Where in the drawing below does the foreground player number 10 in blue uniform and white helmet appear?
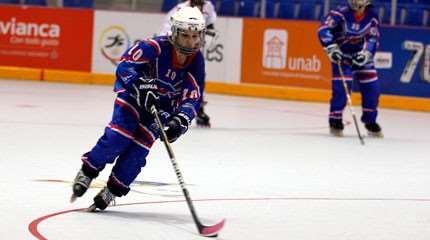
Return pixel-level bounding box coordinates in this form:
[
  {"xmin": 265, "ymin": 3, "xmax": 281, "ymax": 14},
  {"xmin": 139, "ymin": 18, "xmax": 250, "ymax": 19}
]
[{"xmin": 71, "ymin": 7, "xmax": 205, "ymax": 210}]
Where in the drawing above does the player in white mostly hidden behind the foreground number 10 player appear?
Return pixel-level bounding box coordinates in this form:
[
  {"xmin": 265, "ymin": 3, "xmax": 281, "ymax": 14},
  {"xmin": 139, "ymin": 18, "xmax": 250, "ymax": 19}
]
[{"xmin": 159, "ymin": 0, "xmax": 218, "ymax": 127}]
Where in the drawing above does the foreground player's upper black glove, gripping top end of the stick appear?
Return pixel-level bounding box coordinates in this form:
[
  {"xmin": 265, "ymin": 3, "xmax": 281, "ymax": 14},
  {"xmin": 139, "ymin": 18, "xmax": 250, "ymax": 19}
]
[{"xmin": 133, "ymin": 78, "xmax": 160, "ymax": 112}]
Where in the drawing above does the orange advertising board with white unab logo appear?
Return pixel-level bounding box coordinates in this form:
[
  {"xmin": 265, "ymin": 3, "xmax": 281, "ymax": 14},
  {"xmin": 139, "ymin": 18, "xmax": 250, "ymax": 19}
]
[{"xmin": 241, "ymin": 19, "xmax": 331, "ymax": 89}]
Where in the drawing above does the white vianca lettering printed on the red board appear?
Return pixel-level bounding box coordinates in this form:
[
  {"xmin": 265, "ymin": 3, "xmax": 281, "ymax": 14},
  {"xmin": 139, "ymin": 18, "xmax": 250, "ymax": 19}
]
[{"xmin": 0, "ymin": 17, "xmax": 61, "ymax": 38}]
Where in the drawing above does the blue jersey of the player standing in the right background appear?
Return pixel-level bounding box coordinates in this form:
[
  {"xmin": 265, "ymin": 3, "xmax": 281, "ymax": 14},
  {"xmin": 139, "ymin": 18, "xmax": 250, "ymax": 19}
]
[{"xmin": 318, "ymin": 6, "xmax": 379, "ymax": 56}]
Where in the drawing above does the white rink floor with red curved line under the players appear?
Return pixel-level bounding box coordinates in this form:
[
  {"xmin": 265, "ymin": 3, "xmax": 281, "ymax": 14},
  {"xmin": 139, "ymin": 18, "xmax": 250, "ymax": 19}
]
[{"xmin": 0, "ymin": 80, "xmax": 430, "ymax": 240}]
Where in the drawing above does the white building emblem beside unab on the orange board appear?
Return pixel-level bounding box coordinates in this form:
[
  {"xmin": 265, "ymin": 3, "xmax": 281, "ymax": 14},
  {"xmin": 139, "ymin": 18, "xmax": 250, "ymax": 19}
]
[{"xmin": 263, "ymin": 29, "xmax": 288, "ymax": 69}]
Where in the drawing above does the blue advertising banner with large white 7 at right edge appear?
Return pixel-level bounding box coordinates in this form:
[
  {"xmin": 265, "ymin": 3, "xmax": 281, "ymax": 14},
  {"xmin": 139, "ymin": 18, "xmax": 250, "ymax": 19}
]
[{"xmin": 376, "ymin": 27, "xmax": 430, "ymax": 98}]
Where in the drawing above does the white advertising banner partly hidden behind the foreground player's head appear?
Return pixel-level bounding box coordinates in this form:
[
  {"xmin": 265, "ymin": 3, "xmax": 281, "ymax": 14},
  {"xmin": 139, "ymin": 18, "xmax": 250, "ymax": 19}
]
[{"xmin": 92, "ymin": 11, "xmax": 242, "ymax": 83}]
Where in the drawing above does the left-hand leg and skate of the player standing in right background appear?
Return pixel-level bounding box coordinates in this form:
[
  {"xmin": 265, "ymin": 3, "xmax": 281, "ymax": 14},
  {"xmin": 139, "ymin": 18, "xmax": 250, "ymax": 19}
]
[{"xmin": 329, "ymin": 64, "xmax": 352, "ymax": 136}]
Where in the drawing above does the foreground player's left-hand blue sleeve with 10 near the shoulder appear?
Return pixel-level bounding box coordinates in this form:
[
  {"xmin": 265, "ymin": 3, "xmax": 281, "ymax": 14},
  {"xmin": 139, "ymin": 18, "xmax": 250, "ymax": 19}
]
[{"xmin": 115, "ymin": 39, "xmax": 161, "ymax": 91}]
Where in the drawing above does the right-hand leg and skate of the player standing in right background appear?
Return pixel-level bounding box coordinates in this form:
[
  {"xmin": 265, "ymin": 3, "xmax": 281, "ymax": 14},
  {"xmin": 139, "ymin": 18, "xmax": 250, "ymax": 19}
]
[{"xmin": 355, "ymin": 69, "xmax": 383, "ymax": 137}]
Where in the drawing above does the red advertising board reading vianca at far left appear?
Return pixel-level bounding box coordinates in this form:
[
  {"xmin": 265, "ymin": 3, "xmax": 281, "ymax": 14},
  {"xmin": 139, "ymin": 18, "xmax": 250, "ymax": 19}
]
[{"xmin": 0, "ymin": 6, "xmax": 93, "ymax": 71}]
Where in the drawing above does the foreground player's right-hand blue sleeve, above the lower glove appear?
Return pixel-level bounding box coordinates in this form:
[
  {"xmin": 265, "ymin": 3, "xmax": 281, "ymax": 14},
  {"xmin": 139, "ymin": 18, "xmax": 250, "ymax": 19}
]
[{"xmin": 179, "ymin": 53, "xmax": 205, "ymax": 122}]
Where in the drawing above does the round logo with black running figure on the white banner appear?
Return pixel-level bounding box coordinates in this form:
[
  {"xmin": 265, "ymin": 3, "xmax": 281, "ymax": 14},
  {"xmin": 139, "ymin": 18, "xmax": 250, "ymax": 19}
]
[{"xmin": 99, "ymin": 25, "xmax": 130, "ymax": 66}]
